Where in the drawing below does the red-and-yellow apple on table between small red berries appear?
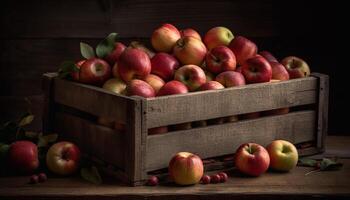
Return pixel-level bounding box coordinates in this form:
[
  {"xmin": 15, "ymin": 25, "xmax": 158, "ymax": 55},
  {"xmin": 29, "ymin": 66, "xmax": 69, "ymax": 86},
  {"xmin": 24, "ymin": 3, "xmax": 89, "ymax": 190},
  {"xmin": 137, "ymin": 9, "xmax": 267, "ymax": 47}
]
[{"xmin": 168, "ymin": 152, "xmax": 204, "ymax": 185}]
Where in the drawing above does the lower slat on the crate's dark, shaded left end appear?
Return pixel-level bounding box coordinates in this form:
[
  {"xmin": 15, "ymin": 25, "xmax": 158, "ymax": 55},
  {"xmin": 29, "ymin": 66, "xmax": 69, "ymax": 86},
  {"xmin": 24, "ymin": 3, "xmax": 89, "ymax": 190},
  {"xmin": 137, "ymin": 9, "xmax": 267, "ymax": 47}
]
[{"xmin": 54, "ymin": 112, "xmax": 124, "ymax": 169}]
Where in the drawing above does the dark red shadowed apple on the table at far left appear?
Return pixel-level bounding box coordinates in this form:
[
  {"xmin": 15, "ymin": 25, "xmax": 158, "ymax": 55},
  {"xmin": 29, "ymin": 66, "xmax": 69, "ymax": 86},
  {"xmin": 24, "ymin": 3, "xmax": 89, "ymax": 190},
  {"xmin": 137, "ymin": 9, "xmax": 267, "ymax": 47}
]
[{"xmin": 8, "ymin": 141, "xmax": 39, "ymax": 174}]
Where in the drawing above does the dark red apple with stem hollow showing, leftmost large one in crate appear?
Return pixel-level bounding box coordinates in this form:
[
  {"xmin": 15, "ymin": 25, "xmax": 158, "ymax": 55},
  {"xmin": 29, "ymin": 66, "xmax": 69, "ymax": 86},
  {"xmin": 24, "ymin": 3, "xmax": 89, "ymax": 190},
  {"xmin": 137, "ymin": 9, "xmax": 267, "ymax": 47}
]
[{"xmin": 79, "ymin": 58, "xmax": 112, "ymax": 85}]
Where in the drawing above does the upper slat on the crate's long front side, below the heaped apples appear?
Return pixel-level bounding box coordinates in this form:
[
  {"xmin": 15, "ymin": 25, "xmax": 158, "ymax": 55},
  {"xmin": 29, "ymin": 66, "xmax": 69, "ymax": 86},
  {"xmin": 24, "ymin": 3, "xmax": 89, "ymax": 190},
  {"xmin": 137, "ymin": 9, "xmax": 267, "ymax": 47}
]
[{"xmin": 146, "ymin": 77, "xmax": 317, "ymax": 128}]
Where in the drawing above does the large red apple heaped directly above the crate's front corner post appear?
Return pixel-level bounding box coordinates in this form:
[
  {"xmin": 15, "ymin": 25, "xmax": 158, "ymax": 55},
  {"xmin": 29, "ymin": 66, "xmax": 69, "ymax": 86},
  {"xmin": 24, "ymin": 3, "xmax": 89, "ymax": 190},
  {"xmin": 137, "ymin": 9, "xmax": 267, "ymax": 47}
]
[{"xmin": 117, "ymin": 48, "xmax": 151, "ymax": 82}]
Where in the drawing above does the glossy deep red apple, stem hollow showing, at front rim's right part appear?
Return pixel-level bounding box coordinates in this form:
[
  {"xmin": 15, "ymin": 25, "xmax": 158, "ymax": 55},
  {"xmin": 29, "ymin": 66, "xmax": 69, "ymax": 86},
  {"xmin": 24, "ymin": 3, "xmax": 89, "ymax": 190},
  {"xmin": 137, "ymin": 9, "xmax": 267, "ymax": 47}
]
[{"xmin": 242, "ymin": 56, "xmax": 272, "ymax": 83}]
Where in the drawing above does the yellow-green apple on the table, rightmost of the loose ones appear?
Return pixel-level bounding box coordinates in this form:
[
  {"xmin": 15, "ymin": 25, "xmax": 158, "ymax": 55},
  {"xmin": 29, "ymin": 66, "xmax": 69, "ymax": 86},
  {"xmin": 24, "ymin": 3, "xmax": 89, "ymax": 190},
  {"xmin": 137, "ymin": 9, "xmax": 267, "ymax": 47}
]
[{"xmin": 266, "ymin": 140, "xmax": 298, "ymax": 172}]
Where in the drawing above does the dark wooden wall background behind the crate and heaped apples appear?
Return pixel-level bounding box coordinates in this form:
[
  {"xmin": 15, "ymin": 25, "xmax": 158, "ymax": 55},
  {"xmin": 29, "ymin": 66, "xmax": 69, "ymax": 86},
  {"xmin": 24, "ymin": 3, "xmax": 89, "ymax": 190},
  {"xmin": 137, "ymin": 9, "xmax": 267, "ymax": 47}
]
[{"xmin": 0, "ymin": 0, "xmax": 350, "ymax": 135}]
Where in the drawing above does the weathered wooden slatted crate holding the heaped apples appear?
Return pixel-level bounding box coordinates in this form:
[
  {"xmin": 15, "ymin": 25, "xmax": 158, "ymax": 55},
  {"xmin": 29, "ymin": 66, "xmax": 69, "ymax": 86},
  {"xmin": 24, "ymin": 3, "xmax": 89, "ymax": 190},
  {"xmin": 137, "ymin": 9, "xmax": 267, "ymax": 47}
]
[{"xmin": 43, "ymin": 73, "xmax": 329, "ymax": 185}]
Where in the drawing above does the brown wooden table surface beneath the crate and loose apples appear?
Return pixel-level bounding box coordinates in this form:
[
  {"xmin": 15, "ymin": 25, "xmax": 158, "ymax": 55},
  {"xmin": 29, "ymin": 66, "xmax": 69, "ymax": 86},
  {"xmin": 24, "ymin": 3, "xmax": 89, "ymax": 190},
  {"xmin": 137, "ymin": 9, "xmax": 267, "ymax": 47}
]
[{"xmin": 0, "ymin": 136, "xmax": 350, "ymax": 200}]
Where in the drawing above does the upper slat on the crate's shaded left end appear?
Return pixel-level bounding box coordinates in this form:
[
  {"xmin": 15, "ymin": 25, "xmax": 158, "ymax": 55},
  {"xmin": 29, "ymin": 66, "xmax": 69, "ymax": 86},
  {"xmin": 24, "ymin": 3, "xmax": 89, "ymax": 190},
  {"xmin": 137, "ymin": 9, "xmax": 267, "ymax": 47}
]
[{"xmin": 54, "ymin": 78, "xmax": 134, "ymax": 122}]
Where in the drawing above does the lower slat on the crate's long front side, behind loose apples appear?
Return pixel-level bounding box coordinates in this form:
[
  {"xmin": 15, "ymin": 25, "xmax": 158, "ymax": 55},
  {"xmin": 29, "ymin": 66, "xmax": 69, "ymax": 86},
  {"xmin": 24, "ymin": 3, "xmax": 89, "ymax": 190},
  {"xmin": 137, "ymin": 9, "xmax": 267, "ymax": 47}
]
[{"xmin": 146, "ymin": 111, "xmax": 316, "ymax": 171}]
